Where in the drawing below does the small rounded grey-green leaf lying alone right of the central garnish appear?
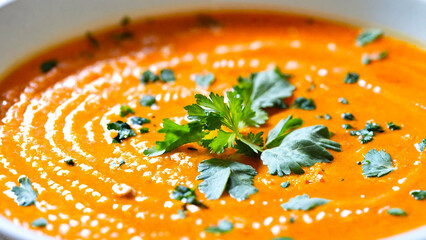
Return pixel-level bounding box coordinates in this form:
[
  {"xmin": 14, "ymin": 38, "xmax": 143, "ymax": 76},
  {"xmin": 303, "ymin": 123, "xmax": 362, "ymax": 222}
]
[{"xmin": 362, "ymin": 149, "xmax": 394, "ymax": 177}]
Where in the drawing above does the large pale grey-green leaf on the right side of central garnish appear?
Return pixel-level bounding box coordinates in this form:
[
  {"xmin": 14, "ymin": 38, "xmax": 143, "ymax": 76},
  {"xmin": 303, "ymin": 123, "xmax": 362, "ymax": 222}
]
[{"xmin": 260, "ymin": 125, "xmax": 341, "ymax": 177}]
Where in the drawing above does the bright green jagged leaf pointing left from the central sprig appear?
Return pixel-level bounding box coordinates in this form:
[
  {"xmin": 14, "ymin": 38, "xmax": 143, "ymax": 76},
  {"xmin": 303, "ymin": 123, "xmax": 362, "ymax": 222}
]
[{"xmin": 143, "ymin": 119, "xmax": 206, "ymax": 157}]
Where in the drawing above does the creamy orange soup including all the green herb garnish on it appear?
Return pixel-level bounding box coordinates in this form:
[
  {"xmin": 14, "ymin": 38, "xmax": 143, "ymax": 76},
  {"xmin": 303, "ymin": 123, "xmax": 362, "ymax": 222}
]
[{"xmin": 0, "ymin": 12, "xmax": 426, "ymax": 240}]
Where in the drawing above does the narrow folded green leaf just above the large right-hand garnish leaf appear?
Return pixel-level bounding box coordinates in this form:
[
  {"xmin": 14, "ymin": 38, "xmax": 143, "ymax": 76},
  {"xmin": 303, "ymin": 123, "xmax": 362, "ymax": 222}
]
[{"xmin": 265, "ymin": 115, "xmax": 303, "ymax": 148}]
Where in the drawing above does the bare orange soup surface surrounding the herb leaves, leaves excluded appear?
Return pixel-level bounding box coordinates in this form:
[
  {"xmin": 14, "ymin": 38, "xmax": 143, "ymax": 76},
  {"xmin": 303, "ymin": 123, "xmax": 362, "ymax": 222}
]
[{"xmin": 0, "ymin": 12, "xmax": 426, "ymax": 240}]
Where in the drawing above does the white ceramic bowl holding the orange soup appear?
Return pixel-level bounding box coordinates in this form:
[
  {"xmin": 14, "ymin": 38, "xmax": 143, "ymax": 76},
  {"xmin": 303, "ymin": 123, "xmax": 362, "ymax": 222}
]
[{"xmin": 0, "ymin": 0, "xmax": 426, "ymax": 240}]
